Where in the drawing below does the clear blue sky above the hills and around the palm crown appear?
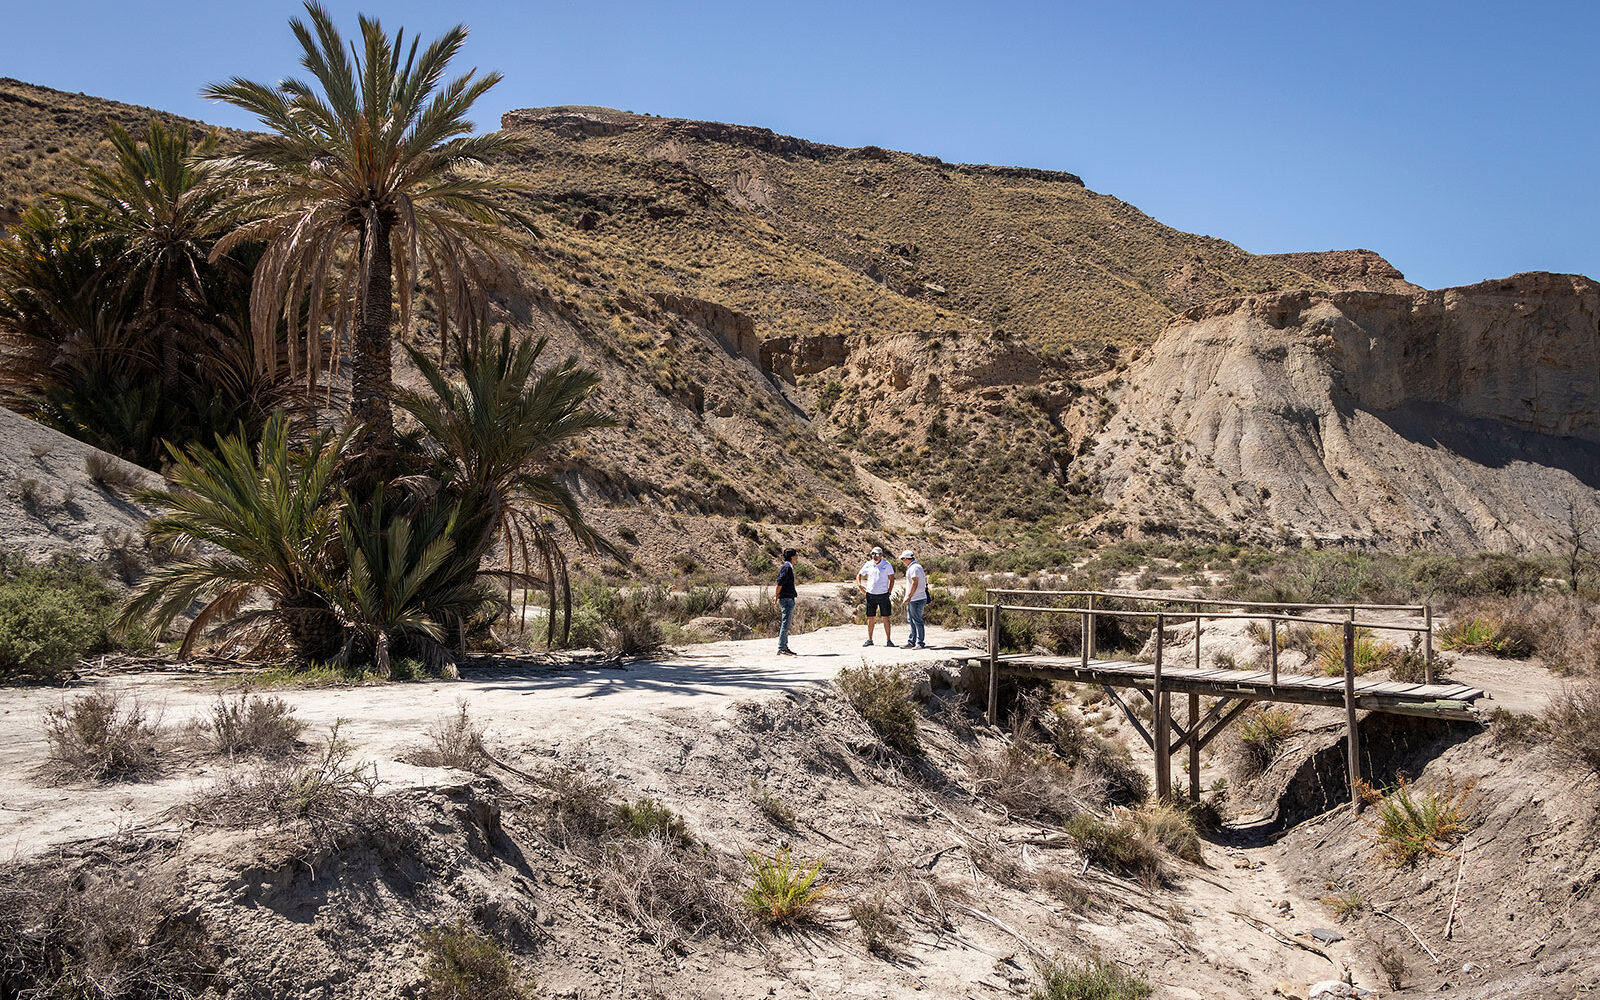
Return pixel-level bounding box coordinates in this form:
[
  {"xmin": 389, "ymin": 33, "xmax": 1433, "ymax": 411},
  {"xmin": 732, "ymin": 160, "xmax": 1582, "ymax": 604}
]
[{"xmin": 0, "ymin": 0, "xmax": 1600, "ymax": 288}]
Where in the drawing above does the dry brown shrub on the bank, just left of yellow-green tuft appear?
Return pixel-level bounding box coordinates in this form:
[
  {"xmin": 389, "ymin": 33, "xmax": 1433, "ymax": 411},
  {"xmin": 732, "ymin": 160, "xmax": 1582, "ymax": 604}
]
[{"xmin": 597, "ymin": 832, "xmax": 746, "ymax": 947}]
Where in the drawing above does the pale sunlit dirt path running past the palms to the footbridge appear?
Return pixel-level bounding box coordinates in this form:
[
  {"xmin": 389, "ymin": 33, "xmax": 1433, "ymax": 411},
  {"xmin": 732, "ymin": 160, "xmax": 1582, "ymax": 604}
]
[{"xmin": 0, "ymin": 626, "xmax": 981, "ymax": 858}]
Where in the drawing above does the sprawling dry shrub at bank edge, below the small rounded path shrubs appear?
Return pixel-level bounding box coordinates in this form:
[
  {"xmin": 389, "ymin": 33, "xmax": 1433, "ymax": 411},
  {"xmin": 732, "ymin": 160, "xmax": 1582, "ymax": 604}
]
[{"xmin": 187, "ymin": 723, "xmax": 418, "ymax": 853}]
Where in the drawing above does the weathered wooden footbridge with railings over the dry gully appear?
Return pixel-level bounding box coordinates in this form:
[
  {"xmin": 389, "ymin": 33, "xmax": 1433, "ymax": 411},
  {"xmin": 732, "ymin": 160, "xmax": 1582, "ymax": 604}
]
[{"xmin": 973, "ymin": 589, "xmax": 1485, "ymax": 810}]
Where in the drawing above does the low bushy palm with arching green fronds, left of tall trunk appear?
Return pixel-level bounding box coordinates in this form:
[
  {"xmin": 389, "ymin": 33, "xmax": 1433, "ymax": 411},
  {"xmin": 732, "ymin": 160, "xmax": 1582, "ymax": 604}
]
[{"xmin": 115, "ymin": 411, "xmax": 349, "ymax": 659}]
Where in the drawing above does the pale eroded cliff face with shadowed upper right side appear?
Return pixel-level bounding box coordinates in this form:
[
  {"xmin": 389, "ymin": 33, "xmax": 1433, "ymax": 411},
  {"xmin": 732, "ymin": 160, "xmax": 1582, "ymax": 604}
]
[{"xmin": 1093, "ymin": 274, "xmax": 1600, "ymax": 550}]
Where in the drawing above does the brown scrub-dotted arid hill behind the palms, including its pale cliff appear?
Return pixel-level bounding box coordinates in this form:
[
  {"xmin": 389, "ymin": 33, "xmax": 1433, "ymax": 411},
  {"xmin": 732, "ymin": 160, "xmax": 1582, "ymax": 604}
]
[{"xmin": 0, "ymin": 80, "xmax": 1595, "ymax": 573}]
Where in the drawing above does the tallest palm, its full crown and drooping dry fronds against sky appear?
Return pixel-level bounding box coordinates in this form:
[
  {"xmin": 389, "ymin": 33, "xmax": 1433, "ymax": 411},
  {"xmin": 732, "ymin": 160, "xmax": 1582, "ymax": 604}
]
[{"xmin": 203, "ymin": 2, "xmax": 531, "ymax": 453}]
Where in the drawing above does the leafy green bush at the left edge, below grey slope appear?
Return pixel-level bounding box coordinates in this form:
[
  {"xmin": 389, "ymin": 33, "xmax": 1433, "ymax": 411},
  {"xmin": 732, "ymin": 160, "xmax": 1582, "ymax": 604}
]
[{"xmin": 0, "ymin": 554, "xmax": 117, "ymax": 678}]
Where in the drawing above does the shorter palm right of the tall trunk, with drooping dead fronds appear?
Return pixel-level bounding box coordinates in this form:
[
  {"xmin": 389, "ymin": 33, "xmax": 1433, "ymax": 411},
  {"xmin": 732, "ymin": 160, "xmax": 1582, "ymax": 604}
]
[{"xmin": 395, "ymin": 330, "xmax": 616, "ymax": 642}]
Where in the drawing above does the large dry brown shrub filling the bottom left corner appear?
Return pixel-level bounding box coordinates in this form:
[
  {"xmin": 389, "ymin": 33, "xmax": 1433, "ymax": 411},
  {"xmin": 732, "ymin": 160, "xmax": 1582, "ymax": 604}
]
[{"xmin": 0, "ymin": 854, "xmax": 221, "ymax": 1000}]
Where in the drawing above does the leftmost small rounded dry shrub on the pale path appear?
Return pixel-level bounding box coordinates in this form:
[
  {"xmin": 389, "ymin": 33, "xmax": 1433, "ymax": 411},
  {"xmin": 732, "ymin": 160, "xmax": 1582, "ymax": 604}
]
[{"xmin": 43, "ymin": 691, "xmax": 165, "ymax": 782}]
